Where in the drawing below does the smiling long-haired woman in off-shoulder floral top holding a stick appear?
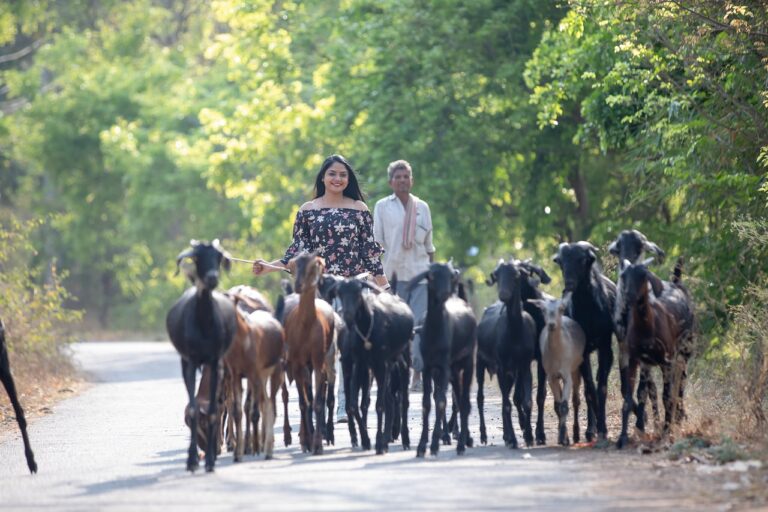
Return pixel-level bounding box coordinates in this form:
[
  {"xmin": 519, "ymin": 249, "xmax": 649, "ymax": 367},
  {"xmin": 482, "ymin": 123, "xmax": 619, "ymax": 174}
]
[{"xmin": 253, "ymin": 155, "xmax": 389, "ymax": 289}]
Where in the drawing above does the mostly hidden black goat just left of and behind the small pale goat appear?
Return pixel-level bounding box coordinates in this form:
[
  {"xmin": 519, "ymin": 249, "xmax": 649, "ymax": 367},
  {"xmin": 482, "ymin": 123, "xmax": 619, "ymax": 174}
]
[{"xmin": 518, "ymin": 260, "xmax": 552, "ymax": 445}]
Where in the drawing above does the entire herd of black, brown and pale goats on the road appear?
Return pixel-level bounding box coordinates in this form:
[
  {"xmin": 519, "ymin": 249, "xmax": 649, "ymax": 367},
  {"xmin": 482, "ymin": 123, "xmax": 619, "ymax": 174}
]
[{"xmin": 0, "ymin": 230, "xmax": 695, "ymax": 472}]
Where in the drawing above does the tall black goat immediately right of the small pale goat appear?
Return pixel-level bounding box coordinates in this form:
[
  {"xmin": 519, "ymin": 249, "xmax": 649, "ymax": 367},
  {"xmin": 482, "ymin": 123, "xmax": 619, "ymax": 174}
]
[{"xmin": 553, "ymin": 242, "xmax": 623, "ymax": 441}]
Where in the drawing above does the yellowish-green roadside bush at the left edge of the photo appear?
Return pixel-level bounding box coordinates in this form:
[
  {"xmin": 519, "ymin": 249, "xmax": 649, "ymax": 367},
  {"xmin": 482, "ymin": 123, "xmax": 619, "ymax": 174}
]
[{"xmin": 0, "ymin": 210, "xmax": 81, "ymax": 357}]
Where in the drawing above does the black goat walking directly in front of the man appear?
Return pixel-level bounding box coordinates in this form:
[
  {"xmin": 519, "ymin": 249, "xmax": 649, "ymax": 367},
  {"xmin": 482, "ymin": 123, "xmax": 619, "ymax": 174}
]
[{"xmin": 408, "ymin": 263, "xmax": 477, "ymax": 457}]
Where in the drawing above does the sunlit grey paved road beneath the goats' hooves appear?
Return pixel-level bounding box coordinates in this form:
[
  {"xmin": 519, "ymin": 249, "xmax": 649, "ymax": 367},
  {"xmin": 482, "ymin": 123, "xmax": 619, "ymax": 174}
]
[{"xmin": 0, "ymin": 342, "xmax": 716, "ymax": 512}]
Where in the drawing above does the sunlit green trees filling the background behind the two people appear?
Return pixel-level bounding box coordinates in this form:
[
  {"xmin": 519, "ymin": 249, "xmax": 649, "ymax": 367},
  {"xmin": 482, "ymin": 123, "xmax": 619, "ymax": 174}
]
[{"xmin": 0, "ymin": 0, "xmax": 768, "ymax": 376}]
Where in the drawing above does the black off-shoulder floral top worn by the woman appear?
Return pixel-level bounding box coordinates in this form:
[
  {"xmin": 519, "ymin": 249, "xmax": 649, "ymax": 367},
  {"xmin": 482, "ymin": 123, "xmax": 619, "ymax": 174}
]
[{"xmin": 280, "ymin": 208, "xmax": 384, "ymax": 277}]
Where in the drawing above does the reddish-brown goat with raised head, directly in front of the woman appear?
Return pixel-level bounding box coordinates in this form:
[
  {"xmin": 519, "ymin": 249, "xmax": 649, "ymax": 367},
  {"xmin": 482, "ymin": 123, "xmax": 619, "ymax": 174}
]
[{"xmin": 285, "ymin": 252, "xmax": 336, "ymax": 455}]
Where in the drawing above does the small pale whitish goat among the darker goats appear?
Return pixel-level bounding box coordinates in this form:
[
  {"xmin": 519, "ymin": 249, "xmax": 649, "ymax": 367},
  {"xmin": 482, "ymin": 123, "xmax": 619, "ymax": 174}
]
[{"xmin": 528, "ymin": 293, "xmax": 586, "ymax": 446}]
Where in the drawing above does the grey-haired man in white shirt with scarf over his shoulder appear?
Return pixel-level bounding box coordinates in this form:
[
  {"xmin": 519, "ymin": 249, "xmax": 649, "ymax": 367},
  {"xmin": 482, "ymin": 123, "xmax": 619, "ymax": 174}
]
[{"xmin": 373, "ymin": 160, "xmax": 435, "ymax": 391}]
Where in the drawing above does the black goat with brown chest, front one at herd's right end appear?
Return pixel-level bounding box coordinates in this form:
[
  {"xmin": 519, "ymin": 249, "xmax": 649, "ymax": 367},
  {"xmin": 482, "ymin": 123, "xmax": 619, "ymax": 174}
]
[{"xmin": 617, "ymin": 260, "xmax": 694, "ymax": 448}]
